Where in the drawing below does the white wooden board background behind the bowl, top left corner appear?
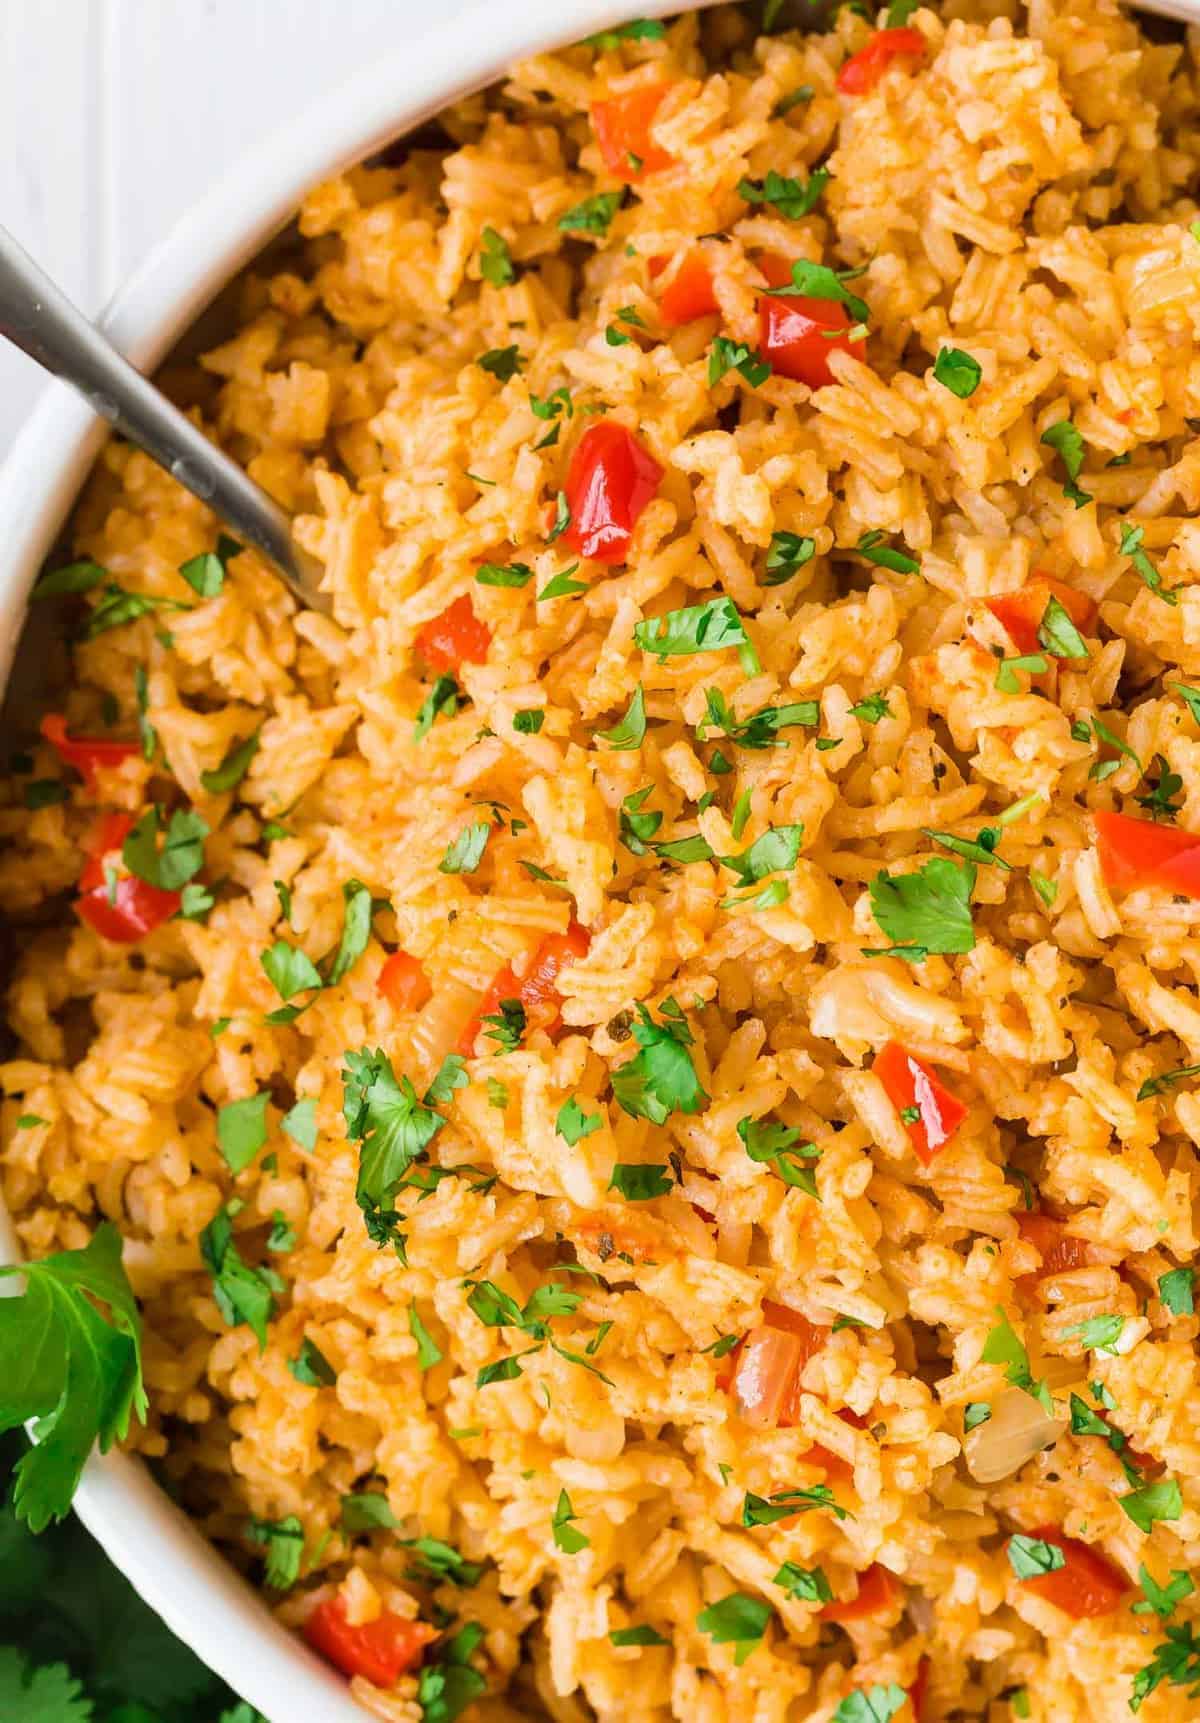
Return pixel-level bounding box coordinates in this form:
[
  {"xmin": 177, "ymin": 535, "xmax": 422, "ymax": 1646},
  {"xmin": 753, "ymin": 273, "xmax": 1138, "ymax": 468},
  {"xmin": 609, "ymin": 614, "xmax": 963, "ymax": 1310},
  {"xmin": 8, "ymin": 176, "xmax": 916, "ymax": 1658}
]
[{"xmin": 0, "ymin": 0, "xmax": 472, "ymax": 458}]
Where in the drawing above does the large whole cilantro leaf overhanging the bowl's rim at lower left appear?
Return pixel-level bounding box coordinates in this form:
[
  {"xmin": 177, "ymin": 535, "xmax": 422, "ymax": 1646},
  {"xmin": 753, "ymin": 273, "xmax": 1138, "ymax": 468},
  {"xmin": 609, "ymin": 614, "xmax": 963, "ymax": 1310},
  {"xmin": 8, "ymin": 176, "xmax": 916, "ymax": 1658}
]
[{"xmin": 0, "ymin": 1222, "xmax": 147, "ymax": 1532}]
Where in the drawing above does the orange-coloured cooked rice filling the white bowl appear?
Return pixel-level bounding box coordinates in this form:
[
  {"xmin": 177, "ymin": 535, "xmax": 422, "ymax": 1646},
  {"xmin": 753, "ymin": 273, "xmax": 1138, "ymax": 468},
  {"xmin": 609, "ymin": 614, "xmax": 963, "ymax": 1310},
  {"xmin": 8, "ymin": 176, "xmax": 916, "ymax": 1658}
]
[{"xmin": 0, "ymin": 0, "xmax": 1200, "ymax": 1723}]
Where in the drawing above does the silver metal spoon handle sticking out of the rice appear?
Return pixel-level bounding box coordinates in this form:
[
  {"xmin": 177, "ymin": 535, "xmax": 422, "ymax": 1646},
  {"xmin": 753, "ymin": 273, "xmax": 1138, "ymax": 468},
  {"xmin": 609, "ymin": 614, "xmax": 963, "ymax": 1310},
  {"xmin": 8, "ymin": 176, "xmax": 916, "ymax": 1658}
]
[{"xmin": 0, "ymin": 227, "xmax": 329, "ymax": 612}]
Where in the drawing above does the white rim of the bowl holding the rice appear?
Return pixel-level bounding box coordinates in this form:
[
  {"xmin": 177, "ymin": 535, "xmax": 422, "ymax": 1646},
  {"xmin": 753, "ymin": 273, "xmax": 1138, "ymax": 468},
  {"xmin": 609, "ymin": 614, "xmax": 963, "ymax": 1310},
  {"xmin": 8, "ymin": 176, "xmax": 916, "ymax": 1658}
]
[{"xmin": 0, "ymin": 0, "xmax": 682, "ymax": 1723}]
